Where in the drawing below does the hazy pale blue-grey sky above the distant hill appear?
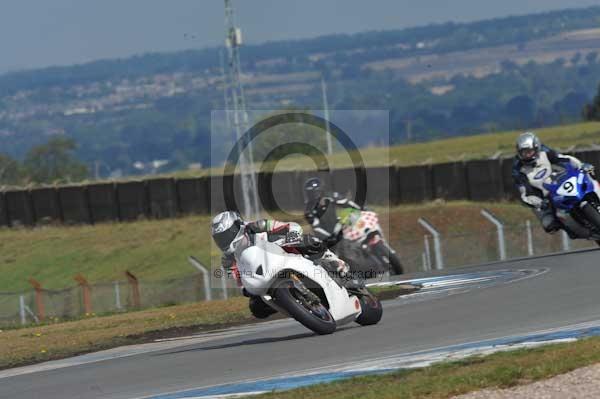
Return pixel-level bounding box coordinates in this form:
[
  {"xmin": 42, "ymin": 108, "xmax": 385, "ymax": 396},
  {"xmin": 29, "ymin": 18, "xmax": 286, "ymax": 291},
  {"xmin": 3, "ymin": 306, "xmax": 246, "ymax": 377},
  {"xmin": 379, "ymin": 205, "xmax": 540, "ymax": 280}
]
[{"xmin": 0, "ymin": 0, "xmax": 598, "ymax": 72}]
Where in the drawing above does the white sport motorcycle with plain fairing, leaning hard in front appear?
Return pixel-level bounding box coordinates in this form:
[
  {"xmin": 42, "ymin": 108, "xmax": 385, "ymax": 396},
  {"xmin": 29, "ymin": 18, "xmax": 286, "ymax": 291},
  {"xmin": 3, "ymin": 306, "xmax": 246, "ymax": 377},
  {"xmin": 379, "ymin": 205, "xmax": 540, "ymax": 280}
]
[{"xmin": 232, "ymin": 233, "xmax": 382, "ymax": 334}]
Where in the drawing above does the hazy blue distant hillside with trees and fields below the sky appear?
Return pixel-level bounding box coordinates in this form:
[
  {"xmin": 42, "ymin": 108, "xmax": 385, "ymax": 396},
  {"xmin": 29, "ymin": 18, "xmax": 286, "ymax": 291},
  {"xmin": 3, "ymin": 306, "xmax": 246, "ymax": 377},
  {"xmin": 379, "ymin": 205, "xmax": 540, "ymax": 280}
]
[{"xmin": 0, "ymin": 7, "xmax": 600, "ymax": 178}]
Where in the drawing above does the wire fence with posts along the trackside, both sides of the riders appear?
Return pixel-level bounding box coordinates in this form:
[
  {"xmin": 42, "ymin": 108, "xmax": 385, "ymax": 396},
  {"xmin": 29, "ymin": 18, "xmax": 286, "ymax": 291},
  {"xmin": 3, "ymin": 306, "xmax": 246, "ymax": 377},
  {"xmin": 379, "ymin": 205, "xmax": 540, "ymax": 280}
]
[{"xmin": 0, "ymin": 216, "xmax": 596, "ymax": 326}]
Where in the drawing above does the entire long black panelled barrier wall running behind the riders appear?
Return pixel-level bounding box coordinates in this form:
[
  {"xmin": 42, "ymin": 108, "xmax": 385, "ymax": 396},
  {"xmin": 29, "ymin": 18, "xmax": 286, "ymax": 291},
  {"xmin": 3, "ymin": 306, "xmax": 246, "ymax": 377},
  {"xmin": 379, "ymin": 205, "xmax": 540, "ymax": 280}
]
[{"xmin": 5, "ymin": 151, "xmax": 600, "ymax": 226}]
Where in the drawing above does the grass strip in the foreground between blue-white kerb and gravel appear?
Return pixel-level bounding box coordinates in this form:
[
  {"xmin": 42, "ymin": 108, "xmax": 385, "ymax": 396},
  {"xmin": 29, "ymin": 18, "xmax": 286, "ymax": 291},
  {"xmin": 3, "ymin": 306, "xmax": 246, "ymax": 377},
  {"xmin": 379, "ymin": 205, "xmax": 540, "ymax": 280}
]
[{"xmin": 253, "ymin": 337, "xmax": 600, "ymax": 399}]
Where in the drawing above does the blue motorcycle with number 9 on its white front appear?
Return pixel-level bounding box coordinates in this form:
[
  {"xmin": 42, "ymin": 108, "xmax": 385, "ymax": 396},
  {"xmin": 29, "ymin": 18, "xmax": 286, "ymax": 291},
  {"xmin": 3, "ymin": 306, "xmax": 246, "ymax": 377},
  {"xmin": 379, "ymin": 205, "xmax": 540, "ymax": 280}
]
[{"xmin": 544, "ymin": 163, "xmax": 600, "ymax": 245}]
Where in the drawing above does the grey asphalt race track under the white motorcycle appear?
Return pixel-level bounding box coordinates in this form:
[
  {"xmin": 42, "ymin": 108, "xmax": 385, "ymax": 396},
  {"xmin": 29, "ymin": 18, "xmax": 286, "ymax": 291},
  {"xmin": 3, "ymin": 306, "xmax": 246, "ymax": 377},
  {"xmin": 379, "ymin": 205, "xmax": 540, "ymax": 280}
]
[{"xmin": 0, "ymin": 251, "xmax": 600, "ymax": 399}]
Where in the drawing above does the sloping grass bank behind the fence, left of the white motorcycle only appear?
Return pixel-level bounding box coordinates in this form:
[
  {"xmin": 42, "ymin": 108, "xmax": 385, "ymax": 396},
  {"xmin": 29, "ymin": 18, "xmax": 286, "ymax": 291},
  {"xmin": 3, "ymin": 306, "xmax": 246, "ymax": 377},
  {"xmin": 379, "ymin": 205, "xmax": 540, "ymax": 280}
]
[{"xmin": 0, "ymin": 216, "xmax": 217, "ymax": 292}]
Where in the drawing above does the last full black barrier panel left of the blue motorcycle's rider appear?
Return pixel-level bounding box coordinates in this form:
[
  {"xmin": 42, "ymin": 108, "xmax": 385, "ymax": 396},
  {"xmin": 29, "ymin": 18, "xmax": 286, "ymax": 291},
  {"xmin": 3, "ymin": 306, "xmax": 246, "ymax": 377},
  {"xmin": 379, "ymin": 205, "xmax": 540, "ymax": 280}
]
[{"xmin": 466, "ymin": 159, "xmax": 504, "ymax": 201}]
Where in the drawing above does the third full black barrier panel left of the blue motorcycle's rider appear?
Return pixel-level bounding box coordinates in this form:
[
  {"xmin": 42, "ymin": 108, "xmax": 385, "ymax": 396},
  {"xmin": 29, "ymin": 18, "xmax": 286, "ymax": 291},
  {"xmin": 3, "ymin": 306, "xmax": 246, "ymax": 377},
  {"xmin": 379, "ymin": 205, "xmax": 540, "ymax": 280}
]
[{"xmin": 395, "ymin": 166, "xmax": 433, "ymax": 203}]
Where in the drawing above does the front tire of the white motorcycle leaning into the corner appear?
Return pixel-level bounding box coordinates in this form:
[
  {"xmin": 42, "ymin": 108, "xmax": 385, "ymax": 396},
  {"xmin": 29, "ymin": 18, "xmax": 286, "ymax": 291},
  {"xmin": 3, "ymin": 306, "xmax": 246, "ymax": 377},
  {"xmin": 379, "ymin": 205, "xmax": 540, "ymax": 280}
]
[{"xmin": 274, "ymin": 279, "xmax": 337, "ymax": 335}]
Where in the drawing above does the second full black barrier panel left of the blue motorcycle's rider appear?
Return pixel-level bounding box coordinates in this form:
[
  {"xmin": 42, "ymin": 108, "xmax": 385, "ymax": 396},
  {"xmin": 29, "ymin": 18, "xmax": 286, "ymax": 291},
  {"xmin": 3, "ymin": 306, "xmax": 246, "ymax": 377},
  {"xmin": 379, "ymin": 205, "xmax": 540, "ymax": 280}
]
[{"xmin": 431, "ymin": 162, "xmax": 469, "ymax": 200}]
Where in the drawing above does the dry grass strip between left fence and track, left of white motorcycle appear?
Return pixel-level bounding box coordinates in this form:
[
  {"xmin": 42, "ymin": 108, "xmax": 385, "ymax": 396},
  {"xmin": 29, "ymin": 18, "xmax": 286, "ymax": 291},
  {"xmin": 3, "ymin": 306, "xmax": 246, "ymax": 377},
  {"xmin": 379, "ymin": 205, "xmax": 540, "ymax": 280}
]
[{"xmin": 0, "ymin": 297, "xmax": 254, "ymax": 369}]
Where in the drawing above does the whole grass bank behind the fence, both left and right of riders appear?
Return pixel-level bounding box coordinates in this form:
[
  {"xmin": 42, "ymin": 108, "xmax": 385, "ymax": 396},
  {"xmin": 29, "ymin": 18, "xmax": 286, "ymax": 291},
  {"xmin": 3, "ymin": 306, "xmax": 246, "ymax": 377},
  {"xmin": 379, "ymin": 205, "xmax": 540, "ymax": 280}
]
[{"xmin": 0, "ymin": 202, "xmax": 529, "ymax": 292}]
